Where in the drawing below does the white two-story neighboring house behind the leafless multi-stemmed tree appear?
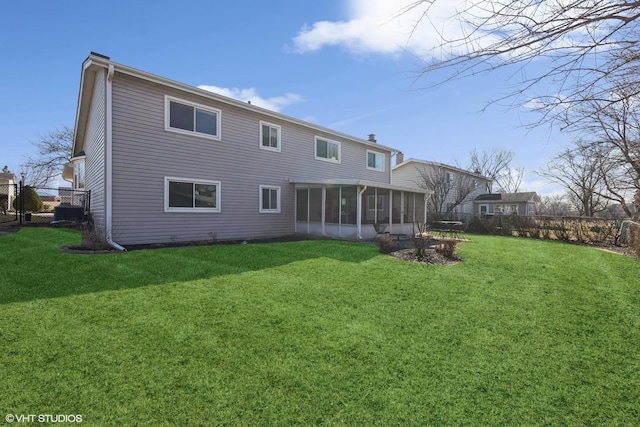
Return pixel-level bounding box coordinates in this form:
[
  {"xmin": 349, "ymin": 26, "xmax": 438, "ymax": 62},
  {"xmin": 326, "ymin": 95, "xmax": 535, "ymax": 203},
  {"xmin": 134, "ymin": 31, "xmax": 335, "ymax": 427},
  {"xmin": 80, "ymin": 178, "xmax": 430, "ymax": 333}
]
[{"xmin": 391, "ymin": 158, "xmax": 492, "ymax": 214}]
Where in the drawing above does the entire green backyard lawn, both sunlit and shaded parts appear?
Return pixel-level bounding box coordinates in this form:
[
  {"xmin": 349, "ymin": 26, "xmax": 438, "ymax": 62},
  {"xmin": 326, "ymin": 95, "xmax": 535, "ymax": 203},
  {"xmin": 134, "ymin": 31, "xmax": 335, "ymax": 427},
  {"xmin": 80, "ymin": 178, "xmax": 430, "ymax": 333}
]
[{"xmin": 0, "ymin": 228, "xmax": 640, "ymax": 426}]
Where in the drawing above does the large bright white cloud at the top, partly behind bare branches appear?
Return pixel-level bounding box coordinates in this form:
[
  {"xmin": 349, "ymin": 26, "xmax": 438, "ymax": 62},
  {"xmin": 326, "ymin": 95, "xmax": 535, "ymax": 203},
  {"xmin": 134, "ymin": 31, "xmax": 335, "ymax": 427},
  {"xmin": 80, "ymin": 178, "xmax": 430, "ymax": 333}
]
[{"xmin": 293, "ymin": 0, "xmax": 585, "ymax": 60}]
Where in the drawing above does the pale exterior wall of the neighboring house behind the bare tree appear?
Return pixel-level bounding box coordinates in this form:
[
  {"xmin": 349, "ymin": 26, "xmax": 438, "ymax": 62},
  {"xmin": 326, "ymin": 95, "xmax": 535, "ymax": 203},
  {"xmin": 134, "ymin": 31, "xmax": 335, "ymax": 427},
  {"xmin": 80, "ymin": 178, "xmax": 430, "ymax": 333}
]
[{"xmin": 392, "ymin": 160, "xmax": 491, "ymax": 214}]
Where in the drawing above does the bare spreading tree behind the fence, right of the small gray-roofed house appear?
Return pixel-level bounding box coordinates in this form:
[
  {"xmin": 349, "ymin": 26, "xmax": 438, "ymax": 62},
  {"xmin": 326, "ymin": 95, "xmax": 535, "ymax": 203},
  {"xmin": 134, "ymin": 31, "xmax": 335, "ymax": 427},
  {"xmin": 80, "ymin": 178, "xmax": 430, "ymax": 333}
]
[{"xmin": 538, "ymin": 144, "xmax": 608, "ymax": 217}]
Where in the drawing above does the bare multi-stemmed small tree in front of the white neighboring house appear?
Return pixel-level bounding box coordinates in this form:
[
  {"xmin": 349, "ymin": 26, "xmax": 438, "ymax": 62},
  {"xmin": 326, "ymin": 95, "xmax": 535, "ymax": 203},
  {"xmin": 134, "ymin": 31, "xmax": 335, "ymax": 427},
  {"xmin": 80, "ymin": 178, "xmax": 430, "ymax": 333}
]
[{"xmin": 416, "ymin": 166, "xmax": 477, "ymax": 216}]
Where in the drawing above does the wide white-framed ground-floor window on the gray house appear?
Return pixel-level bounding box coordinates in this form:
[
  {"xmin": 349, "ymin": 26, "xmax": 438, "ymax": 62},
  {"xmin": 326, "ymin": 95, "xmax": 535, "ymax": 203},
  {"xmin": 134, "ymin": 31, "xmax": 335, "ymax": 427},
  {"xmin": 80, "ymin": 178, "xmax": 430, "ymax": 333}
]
[{"xmin": 164, "ymin": 177, "xmax": 220, "ymax": 212}]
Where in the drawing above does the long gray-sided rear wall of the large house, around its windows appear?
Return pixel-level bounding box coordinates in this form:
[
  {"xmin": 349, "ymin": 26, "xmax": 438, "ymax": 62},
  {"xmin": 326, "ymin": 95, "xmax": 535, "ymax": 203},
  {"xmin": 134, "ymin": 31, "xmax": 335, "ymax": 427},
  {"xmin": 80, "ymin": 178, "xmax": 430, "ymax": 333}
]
[{"xmin": 112, "ymin": 72, "xmax": 391, "ymax": 245}]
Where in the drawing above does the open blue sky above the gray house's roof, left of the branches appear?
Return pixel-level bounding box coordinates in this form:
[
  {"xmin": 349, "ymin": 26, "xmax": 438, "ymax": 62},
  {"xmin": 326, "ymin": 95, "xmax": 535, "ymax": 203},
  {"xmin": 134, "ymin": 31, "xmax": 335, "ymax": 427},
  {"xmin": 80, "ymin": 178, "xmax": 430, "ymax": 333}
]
[{"xmin": 0, "ymin": 0, "xmax": 568, "ymax": 194}]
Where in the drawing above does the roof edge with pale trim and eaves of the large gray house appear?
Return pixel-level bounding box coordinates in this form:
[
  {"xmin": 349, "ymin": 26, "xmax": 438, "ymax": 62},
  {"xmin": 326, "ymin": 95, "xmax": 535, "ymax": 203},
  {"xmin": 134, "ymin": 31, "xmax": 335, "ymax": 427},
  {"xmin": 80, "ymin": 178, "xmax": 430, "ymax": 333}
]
[{"xmin": 73, "ymin": 52, "xmax": 399, "ymax": 156}]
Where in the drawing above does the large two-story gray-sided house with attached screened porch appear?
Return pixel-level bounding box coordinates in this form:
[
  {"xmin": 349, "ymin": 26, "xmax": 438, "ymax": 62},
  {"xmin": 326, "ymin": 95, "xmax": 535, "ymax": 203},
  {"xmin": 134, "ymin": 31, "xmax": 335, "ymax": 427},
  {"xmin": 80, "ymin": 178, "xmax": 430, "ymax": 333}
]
[{"xmin": 63, "ymin": 53, "xmax": 426, "ymax": 247}]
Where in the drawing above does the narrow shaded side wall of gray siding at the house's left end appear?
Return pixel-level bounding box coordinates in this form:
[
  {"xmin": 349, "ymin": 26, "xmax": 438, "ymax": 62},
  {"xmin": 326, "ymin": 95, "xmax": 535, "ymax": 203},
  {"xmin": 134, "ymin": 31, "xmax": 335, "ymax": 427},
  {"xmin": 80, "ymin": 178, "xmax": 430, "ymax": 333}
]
[{"xmin": 84, "ymin": 70, "xmax": 106, "ymax": 237}]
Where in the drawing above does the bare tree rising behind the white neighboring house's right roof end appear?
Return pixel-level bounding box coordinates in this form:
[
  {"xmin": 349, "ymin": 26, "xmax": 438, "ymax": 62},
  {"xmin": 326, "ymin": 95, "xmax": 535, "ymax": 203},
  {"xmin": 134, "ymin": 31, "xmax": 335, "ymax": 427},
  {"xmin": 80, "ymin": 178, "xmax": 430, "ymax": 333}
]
[{"xmin": 469, "ymin": 148, "xmax": 524, "ymax": 193}]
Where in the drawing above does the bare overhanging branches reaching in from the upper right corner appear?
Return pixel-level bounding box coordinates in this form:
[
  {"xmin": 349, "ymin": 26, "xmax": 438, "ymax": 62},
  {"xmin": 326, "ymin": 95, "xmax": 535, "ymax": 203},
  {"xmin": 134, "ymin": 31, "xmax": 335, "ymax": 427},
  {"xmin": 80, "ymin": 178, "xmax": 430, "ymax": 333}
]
[{"xmin": 398, "ymin": 0, "xmax": 640, "ymax": 127}]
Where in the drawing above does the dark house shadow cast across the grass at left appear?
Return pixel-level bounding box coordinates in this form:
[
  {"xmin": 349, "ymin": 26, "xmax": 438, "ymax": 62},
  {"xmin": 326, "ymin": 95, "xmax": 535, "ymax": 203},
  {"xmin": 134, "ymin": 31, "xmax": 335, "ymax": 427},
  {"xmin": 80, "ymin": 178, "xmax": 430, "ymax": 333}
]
[{"xmin": 0, "ymin": 228, "xmax": 378, "ymax": 304}]
